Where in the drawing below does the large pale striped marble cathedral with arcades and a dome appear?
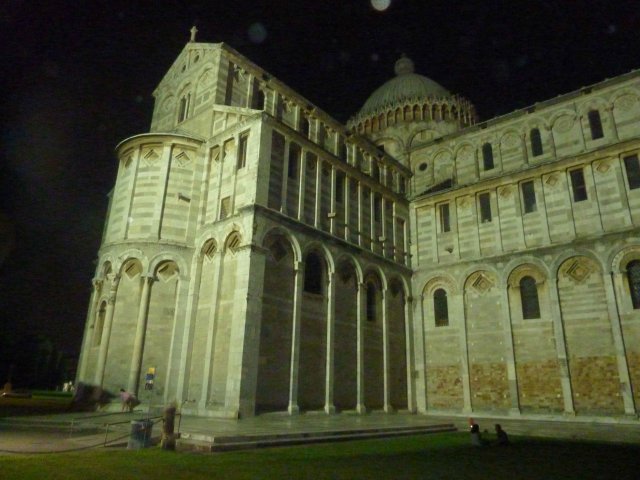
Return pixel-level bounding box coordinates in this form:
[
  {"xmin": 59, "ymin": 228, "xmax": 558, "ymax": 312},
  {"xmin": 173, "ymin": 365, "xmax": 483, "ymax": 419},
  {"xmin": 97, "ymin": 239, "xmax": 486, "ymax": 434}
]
[{"xmin": 77, "ymin": 31, "xmax": 640, "ymax": 418}]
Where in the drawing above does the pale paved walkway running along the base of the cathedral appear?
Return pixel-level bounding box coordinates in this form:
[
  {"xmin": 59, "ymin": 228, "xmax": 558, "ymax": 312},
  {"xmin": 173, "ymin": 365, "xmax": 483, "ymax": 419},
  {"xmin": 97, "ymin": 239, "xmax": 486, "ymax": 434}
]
[{"xmin": 0, "ymin": 412, "xmax": 640, "ymax": 454}]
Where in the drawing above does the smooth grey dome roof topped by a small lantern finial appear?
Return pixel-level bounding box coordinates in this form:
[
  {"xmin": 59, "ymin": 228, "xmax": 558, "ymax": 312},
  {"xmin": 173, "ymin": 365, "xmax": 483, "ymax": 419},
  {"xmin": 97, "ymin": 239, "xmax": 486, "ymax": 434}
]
[{"xmin": 358, "ymin": 55, "xmax": 451, "ymax": 117}]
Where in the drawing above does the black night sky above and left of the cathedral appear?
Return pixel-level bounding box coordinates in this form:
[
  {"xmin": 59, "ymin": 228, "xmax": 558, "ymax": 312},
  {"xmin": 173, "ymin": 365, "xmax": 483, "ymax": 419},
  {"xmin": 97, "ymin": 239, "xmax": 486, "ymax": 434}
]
[{"xmin": 0, "ymin": 0, "xmax": 640, "ymax": 355}]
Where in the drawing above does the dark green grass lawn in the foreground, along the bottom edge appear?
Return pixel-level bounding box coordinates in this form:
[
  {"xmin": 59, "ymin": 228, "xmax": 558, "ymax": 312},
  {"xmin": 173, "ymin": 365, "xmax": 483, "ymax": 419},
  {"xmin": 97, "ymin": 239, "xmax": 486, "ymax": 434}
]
[{"xmin": 0, "ymin": 433, "xmax": 640, "ymax": 480}]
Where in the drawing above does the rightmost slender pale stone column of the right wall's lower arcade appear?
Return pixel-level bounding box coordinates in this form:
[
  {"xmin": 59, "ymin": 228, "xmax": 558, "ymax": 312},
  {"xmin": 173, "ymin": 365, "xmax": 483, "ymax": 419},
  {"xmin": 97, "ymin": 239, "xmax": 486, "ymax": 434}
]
[{"xmin": 602, "ymin": 273, "xmax": 636, "ymax": 415}]
